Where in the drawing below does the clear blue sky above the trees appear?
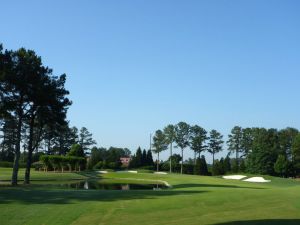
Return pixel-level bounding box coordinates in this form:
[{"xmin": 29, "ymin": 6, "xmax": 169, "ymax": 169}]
[{"xmin": 0, "ymin": 0, "xmax": 300, "ymax": 160}]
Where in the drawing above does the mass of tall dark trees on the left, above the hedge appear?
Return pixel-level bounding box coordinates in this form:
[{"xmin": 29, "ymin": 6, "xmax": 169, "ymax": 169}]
[{"xmin": 0, "ymin": 45, "xmax": 95, "ymax": 185}]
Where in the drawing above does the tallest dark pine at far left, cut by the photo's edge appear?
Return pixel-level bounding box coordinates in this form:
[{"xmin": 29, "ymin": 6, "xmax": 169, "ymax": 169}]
[{"xmin": 0, "ymin": 48, "xmax": 37, "ymax": 185}]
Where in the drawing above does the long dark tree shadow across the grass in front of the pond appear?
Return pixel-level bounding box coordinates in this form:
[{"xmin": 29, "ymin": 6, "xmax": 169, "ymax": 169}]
[{"xmin": 0, "ymin": 188, "xmax": 206, "ymax": 205}]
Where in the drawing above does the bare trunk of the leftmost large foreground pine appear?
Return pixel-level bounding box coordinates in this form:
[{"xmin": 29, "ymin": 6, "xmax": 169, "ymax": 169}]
[{"xmin": 11, "ymin": 103, "xmax": 23, "ymax": 186}]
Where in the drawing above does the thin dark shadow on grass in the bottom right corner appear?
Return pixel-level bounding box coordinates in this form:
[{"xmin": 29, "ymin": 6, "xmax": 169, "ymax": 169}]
[{"xmin": 215, "ymin": 219, "xmax": 300, "ymax": 225}]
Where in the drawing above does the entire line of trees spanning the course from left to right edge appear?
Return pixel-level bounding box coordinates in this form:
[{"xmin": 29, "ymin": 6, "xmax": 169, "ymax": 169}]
[{"xmin": 0, "ymin": 45, "xmax": 300, "ymax": 185}]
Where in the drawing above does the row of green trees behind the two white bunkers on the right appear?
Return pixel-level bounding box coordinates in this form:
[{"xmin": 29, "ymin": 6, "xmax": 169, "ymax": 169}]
[{"xmin": 151, "ymin": 122, "xmax": 300, "ymax": 177}]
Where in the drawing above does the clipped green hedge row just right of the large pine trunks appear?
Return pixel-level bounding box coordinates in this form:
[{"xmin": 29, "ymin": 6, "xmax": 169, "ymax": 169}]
[{"xmin": 36, "ymin": 155, "xmax": 86, "ymax": 172}]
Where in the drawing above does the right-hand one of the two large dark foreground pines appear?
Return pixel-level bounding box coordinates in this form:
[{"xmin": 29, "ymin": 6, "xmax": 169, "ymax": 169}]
[{"xmin": 24, "ymin": 73, "xmax": 71, "ymax": 184}]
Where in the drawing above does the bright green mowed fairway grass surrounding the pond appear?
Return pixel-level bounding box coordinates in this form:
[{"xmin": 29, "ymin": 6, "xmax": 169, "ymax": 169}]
[{"xmin": 0, "ymin": 168, "xmax": 300, "ymax": 225}]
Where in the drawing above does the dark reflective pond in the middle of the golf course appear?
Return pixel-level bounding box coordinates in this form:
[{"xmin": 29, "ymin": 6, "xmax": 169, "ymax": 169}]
[{"xmin": 37, "ymin": 179, "xmax": 168, "ymax": 191}]
